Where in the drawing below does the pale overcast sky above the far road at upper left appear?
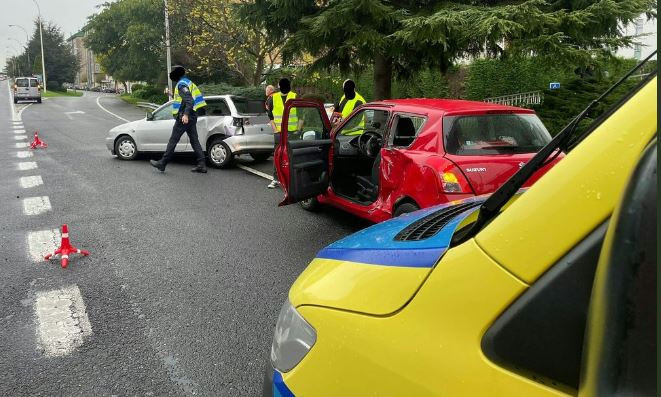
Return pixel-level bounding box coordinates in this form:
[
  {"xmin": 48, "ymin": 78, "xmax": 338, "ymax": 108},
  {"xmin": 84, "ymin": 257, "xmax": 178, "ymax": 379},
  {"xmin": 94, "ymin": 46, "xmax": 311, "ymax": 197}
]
[{"xmin": 0, "ymin": 0, "xmax": 106, "ymax": 70}]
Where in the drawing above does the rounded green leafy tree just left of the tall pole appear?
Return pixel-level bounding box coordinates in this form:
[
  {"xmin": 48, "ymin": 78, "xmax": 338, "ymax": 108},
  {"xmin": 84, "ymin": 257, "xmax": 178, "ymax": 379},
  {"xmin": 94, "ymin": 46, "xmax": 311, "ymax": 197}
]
[{"xmin": 84, "ymin": 0, "xmax": 165, "ymax": 82}]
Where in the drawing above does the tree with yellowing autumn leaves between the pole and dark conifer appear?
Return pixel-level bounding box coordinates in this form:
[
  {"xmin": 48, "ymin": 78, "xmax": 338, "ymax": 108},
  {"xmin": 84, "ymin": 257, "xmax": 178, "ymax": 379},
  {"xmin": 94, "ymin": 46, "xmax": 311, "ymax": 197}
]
[{"xmin": 171, "ymin": 0, "xmax": 283, "ymax": 85}]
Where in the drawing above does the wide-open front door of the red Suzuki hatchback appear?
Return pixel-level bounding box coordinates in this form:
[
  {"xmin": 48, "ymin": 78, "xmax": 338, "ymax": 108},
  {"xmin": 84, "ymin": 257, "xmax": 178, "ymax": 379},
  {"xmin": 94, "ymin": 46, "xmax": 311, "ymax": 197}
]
[{"xmin": 273, "ymin": 100, "xmax": 331, "ymax": 205}]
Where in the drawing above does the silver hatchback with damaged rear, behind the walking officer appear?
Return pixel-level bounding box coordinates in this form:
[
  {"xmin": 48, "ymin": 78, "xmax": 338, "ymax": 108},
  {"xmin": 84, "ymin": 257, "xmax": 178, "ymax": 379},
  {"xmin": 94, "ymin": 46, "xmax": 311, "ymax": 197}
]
[{"xmin": 106, "ymin": 95, "xmax": 274, "ymax": 168}]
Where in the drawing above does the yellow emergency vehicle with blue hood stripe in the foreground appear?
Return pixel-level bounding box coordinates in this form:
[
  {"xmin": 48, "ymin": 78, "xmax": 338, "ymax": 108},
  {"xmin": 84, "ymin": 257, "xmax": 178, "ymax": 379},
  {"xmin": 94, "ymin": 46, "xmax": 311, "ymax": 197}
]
[{"xmin": 263, "ymin": 69, "xmax": 658, "ymax": 397}]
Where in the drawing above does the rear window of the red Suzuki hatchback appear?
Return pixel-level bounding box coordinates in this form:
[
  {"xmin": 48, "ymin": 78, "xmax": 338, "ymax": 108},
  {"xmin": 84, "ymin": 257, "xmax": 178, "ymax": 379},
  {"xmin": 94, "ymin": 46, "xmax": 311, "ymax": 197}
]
[{"xmin": 443, "ymin": 113, "xmax": 551, "ymax": 156}]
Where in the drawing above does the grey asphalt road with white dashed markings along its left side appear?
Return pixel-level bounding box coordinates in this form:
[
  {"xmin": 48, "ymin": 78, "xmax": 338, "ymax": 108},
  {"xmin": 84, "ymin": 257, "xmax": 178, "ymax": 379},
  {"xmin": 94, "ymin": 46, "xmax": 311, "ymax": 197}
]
[{"xmin": 0, "ymin": 82, "xmax": 367, "ymax": 396}]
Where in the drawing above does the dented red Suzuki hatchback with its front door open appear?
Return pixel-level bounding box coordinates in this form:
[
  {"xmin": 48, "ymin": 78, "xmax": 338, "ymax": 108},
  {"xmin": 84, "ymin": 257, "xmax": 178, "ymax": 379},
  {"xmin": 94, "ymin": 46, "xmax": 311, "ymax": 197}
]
[{"xmin": 275, "ymin": 99, "xmax": 562, "ymax": 222}]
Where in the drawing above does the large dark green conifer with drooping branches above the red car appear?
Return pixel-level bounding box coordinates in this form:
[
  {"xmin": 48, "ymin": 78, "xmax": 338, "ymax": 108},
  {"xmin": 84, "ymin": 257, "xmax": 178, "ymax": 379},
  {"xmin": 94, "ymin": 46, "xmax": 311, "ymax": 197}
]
[{"xmin": 242, "ymin": 0, "xmax": 656, "ymax": 99}]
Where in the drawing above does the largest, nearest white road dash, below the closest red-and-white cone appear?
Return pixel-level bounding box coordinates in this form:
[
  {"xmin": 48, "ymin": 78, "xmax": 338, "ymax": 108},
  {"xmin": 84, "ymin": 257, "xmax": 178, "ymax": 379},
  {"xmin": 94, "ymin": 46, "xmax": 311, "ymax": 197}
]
[{"xmin": 34, "ymin": 285, "xmax": 92, "ymax": 357}]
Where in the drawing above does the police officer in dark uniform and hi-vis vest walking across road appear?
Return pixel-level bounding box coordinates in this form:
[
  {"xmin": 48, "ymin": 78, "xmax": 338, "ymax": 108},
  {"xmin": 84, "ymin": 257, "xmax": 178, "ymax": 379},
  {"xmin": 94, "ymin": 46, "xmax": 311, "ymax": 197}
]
[{"xmin": 150, "ymin": 65, "xmax": 207, "ymax": 173}]
